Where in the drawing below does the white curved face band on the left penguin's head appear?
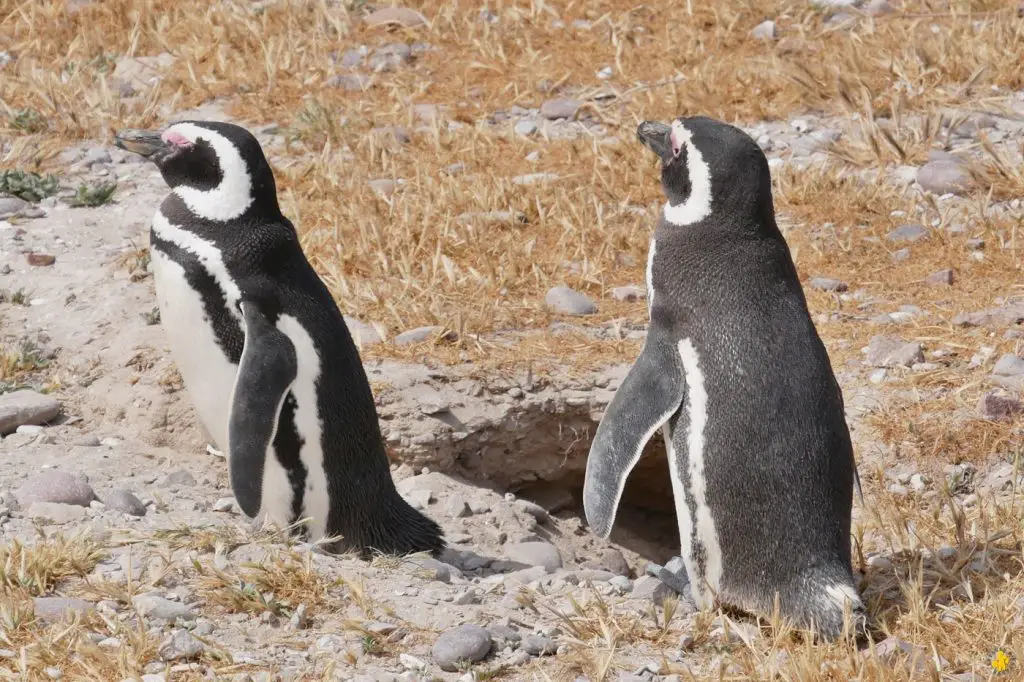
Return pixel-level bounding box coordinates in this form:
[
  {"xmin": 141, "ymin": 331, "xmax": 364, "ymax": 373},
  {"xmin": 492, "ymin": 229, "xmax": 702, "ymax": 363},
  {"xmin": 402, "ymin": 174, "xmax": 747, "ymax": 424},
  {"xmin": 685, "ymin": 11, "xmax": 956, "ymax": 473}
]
[{"xmin": 164, "ymin": 123, "xmax": 253, "ymax": 222}]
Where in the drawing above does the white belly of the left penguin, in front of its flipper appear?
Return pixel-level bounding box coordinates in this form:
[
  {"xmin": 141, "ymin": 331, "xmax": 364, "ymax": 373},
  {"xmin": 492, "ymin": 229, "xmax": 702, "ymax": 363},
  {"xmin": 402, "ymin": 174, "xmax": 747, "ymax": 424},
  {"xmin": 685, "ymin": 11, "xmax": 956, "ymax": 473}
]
[{"xmin": 150, "ymin": 248, "xmax": 239, "ymax": 450}]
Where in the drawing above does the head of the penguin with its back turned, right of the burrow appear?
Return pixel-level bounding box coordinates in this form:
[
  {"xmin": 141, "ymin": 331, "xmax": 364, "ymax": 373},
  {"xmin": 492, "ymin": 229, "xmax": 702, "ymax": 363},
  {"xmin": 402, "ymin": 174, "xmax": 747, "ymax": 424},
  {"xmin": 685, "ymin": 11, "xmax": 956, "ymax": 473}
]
[{"xmin": 637, "ymin": 116, "xmax": 774, "ymax": 231}]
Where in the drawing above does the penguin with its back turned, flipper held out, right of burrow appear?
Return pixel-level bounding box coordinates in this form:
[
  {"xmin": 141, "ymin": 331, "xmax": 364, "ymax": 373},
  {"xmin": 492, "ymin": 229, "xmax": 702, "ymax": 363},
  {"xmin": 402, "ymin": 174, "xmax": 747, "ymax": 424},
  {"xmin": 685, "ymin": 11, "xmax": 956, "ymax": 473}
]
[{"xmin": 584, "ymin": 116, "xmax": 866, "ymax": 641}]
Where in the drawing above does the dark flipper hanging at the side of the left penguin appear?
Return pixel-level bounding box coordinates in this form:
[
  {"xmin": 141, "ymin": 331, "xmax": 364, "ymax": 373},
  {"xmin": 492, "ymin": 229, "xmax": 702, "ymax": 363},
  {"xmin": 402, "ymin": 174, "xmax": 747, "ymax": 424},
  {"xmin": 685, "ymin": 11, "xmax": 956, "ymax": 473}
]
[{"xmin": 226, "ymin": 301, "xmax": 298, "ymax": 517}]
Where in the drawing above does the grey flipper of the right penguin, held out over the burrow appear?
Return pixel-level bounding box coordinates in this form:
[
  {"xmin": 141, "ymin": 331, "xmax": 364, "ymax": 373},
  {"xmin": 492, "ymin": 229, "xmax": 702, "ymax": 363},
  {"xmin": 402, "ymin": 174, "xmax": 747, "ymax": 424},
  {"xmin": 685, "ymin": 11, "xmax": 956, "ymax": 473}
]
[{"xmin": 583, "ymin": 326, "xmax": 686, "ymax": 538}]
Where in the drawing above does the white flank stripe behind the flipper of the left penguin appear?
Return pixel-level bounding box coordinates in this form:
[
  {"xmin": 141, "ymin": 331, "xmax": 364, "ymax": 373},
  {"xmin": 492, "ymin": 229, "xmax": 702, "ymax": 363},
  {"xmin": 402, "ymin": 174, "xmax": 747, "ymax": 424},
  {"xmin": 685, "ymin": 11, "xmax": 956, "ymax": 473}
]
[{"xmin": 278, "ymin": 314, "xmax": 331, "ymax": 538}]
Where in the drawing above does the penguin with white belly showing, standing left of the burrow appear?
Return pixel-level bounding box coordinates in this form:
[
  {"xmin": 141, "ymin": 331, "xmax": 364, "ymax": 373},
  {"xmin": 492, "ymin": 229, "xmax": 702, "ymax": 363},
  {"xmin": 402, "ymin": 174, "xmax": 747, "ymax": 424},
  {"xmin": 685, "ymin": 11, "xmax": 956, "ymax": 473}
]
[{"xmin": 116, "ymin": 121, "xmax": 446, "ymax": 557}]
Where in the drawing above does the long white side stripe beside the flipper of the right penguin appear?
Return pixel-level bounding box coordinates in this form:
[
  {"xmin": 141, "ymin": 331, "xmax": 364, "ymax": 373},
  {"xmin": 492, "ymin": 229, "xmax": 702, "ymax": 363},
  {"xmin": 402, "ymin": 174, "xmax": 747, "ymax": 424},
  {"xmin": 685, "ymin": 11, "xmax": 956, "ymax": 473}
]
[{"xmin": 678, "ymin": 339, "xmax": 722, "ymax": 592}]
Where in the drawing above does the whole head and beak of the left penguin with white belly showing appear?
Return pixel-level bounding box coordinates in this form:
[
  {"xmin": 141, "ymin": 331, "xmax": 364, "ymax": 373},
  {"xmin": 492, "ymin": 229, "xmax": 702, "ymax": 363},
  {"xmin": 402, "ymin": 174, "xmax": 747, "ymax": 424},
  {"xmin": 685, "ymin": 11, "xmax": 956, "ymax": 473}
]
[{"xmin": 115, "ymin": 121, "xmax": 281, "ymax": 222}]
